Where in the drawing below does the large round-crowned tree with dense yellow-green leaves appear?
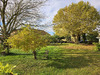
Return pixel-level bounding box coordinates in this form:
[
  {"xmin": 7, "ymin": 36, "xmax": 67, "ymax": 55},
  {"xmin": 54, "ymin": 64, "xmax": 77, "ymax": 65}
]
[{"xmin": 53, "ymin": 1, "xmax": 100, "ymax": 43}]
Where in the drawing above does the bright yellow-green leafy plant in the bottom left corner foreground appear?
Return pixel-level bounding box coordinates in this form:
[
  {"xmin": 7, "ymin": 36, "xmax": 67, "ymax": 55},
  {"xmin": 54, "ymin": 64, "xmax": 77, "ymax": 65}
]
[{"xmin": 0, "ymin": 62, "xmax": 17, "ymax": 75}]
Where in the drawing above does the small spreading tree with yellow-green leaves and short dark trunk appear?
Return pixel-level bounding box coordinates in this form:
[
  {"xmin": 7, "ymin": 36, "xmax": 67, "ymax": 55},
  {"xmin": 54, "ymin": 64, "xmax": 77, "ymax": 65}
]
[{"xmin": 7, "ymin": 26, "xmax": 48, "ymax": 59}]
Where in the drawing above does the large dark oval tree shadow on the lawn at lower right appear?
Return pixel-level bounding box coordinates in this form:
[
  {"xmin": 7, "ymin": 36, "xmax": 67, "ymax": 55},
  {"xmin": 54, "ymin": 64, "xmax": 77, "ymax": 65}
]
[{"xmin": 47, "ymin": 56, "xmax": 93, "ymax": 69}]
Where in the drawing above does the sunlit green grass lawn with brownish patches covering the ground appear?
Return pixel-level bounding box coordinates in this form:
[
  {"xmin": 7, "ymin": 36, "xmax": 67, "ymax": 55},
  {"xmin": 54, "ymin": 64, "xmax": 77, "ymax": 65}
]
[{"xmin": 0, "ymin": 43, "xmax": 100, "ymax": 75}]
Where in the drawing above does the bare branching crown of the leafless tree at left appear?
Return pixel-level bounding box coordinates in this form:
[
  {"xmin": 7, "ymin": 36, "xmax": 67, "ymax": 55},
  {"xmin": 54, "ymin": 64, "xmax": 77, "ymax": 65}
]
[{"xmin": 0, "ymin": 0, "xmax": 46, "ymax": 53}]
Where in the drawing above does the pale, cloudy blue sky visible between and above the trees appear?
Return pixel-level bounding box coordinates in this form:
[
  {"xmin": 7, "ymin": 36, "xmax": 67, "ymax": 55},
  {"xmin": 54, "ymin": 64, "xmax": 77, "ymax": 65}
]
[{"xmin": 42, "ymin": 0, "xmax": 100, "ymax": 35}]
